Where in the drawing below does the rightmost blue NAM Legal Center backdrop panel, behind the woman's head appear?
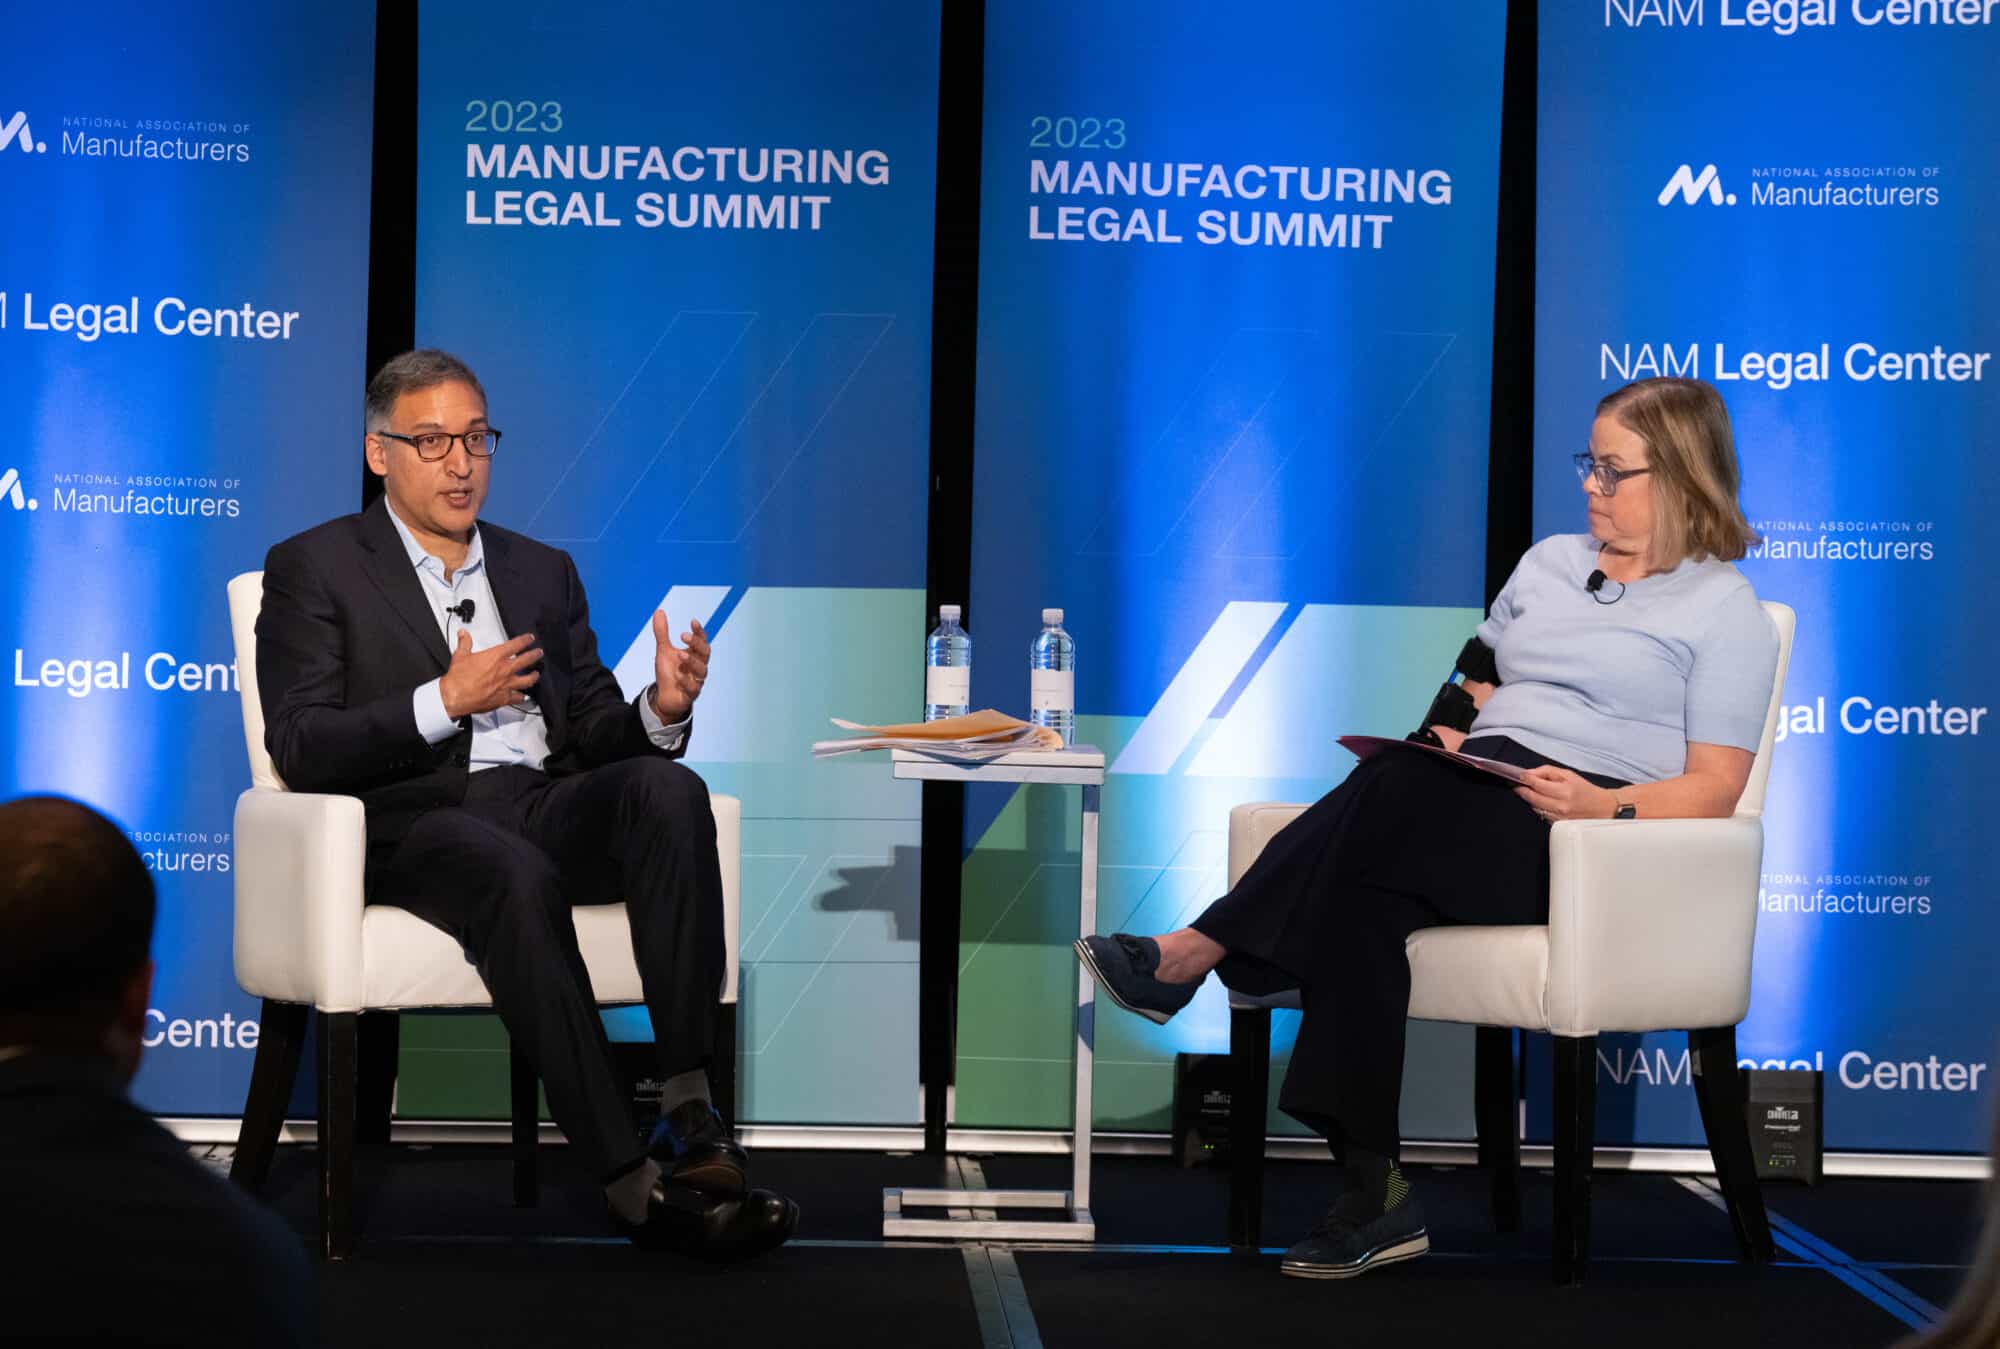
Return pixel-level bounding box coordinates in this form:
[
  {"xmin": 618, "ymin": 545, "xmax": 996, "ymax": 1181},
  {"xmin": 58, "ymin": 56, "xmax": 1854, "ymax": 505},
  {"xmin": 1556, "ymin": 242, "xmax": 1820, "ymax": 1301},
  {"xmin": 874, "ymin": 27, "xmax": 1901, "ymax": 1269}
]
[{"xmin": 1530, "ymin": 0, "xmax": 2000, "ymax": 1151}]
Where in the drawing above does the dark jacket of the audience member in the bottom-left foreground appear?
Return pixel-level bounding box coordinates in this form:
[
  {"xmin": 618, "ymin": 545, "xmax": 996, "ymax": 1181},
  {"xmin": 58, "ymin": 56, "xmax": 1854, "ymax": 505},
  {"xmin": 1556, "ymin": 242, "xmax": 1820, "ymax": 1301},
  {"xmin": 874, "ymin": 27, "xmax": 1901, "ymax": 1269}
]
[{"xmin": 0, "ymin": 1053, "xmax": 320, "ymax": 1349}]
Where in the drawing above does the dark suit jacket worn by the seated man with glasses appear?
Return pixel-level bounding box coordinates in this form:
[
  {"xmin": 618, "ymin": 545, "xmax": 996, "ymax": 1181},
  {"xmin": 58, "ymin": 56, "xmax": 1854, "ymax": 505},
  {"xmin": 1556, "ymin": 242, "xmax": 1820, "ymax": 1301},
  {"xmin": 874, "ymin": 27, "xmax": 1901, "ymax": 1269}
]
[{"xmin": 256, "ymin": 500, "xmax": 692, "ymax": 865}]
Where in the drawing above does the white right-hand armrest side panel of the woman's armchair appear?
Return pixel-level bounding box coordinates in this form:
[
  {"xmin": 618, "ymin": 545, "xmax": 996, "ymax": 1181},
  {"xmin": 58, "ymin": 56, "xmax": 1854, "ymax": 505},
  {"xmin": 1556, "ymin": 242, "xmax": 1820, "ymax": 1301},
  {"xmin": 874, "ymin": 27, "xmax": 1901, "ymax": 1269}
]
[{"xmin": 1548, "ymin": 815, "xmax": 1764, "ymax": 1035}]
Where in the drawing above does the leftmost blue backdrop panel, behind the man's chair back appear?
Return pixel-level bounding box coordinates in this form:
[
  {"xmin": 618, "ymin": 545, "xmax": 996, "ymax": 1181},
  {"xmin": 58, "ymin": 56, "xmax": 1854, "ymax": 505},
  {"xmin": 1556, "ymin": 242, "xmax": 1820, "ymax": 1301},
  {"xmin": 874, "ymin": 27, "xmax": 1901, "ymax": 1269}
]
[{"xmin": 0, "ymin": 0, "xmax": 374, "ymax": 1115}]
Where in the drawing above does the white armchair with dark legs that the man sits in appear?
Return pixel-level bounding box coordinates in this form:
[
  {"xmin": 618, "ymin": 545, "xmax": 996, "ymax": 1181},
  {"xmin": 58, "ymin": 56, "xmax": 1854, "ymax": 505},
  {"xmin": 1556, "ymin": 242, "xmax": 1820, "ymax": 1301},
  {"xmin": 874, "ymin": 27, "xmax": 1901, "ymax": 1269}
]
[{"xmin": 228, "ymin": 572, "xmax": 742, "ymax": 1259}]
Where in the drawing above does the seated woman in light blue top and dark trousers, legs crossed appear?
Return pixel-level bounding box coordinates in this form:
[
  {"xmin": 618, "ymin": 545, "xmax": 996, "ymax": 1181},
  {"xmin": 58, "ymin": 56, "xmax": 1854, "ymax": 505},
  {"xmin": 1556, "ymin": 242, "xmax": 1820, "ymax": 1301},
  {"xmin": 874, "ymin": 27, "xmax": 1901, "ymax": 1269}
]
[{"xmin": 1078, "ymin": 378, "xmax": 1778, "ymax": 1279}]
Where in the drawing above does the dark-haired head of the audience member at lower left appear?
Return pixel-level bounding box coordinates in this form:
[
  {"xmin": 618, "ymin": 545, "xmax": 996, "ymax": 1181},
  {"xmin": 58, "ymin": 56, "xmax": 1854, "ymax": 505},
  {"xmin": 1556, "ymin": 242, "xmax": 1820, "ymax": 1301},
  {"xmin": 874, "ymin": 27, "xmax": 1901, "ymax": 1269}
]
[{"xmin": 0, "ymin": 797, "xmax": 154, "ymax": 1077}]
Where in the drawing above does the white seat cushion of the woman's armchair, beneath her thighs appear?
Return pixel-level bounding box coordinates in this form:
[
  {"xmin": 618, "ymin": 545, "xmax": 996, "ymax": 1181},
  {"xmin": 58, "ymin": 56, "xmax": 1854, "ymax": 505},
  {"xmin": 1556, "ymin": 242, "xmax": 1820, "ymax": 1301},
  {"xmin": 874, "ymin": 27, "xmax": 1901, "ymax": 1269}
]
[{"xmin": 1230, "ymin": 927, "xmax": 1548, "ymax": 1031}]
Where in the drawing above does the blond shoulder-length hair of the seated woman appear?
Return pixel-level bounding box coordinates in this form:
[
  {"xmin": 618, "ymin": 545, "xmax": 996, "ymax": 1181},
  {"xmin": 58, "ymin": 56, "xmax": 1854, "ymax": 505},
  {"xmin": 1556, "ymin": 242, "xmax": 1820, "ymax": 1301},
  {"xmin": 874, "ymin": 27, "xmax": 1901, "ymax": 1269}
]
[{"xmin": 1598, "ymin": 378, "xmax": 1760, "ymax": 570}]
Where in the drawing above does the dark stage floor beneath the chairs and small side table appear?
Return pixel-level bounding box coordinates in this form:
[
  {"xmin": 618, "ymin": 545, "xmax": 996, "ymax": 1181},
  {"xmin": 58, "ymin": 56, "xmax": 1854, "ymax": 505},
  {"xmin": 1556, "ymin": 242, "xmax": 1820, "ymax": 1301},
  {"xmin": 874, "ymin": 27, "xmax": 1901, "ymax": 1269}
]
[{"xmin": 223, "ymin": 1147, "xmax": 1980, "ymax": 1349}]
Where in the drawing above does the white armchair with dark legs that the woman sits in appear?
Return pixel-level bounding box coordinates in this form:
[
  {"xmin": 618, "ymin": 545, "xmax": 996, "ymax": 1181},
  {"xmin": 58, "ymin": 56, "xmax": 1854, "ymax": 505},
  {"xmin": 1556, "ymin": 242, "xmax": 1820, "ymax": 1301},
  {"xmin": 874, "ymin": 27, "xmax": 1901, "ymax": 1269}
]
[{"xmin": 1228, "ymin": 602, "xmax": 1796, "ymax": 1281}]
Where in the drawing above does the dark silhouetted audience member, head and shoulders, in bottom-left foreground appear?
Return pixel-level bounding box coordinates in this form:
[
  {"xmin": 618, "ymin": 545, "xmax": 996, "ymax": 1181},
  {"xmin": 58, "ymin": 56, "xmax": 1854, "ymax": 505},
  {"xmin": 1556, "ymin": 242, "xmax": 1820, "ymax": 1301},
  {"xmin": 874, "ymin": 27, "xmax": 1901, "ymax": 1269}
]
[{"xmin": 0, "ymin": 797, "xmax": 320, "ymax": 1347}]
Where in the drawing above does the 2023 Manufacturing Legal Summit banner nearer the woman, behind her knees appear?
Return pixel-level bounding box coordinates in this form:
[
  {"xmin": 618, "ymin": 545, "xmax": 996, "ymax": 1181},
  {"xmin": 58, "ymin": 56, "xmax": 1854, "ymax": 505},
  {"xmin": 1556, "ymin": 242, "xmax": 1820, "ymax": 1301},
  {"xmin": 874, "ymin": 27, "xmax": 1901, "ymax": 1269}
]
[{"xmin": 956, "ymin": 0, "xmax": 1504, "ymax": 1137}]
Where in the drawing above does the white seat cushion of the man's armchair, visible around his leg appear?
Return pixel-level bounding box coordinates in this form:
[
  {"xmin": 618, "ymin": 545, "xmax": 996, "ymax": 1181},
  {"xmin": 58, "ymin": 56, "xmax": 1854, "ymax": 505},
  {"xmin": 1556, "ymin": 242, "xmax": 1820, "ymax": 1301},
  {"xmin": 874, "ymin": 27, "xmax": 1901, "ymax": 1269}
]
[{"xmin": 362, "ymin": 905, "xmax": 644, "ymax": 1007}]
